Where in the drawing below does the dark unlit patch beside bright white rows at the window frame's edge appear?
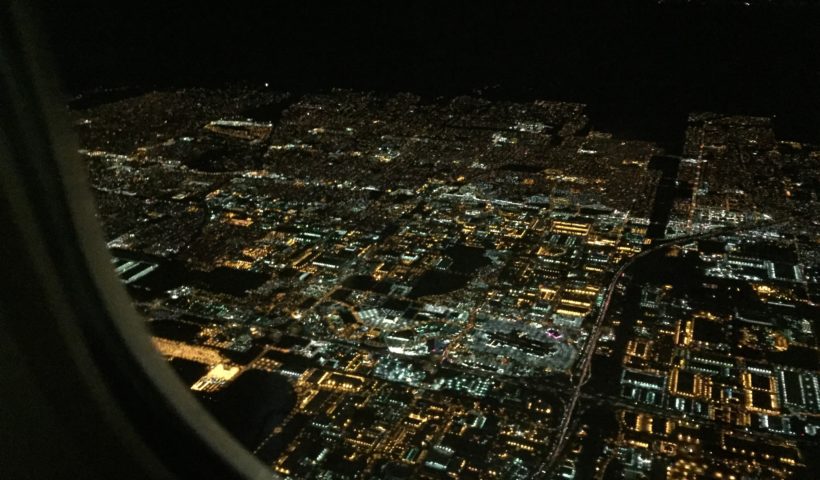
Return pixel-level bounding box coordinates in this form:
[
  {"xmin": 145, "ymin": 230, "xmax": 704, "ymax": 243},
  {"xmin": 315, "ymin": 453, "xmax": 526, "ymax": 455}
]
[{"xmin": 111, "ymin": 249, "xmax": 270, "ymax": 297}]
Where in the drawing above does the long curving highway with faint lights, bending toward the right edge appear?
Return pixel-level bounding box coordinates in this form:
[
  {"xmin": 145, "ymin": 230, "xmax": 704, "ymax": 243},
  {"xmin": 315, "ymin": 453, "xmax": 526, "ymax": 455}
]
[{"xmin": 539, "ymin": 224, "xmax": 773, "ymax": 473}]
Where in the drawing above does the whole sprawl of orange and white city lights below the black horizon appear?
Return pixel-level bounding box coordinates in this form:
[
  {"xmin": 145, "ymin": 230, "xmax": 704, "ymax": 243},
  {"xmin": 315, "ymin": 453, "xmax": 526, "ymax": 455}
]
[{"xmin": 72, "ymin": 86, "xmax": 820, "ymax": 478}]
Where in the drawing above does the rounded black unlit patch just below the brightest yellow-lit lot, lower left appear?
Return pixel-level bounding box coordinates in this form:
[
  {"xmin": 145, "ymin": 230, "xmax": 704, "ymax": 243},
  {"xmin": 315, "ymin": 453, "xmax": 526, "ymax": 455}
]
[{"xmin": 199, "ymin": 370, "xmax": 296, "ymax": 449}]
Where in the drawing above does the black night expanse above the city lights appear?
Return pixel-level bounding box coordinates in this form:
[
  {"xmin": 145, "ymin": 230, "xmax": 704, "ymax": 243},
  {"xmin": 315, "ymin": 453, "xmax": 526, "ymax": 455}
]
[{"xmin": 43, "ymin": 0, "xmax": 820, "ymax": 145}]
